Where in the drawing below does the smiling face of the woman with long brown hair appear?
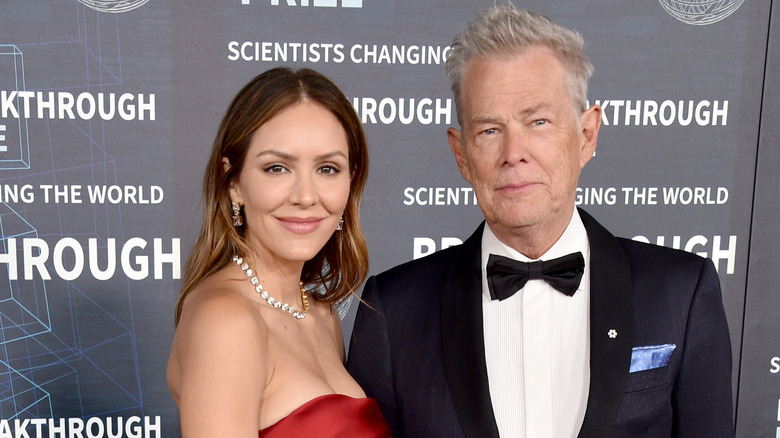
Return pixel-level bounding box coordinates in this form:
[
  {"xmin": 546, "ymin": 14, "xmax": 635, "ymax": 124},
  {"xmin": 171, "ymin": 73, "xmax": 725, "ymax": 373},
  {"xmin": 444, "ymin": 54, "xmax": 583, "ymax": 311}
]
[{"xmin": 225, "ymin": 101, "xmax": 350, "ymax": 262}]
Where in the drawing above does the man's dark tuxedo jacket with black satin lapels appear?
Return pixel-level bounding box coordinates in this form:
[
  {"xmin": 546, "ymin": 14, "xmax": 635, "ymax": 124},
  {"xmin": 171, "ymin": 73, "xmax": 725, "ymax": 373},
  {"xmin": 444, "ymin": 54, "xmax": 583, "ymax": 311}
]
[{"xmin": 347, "ymin": 210, "xmax": 734, "ymax": 438}]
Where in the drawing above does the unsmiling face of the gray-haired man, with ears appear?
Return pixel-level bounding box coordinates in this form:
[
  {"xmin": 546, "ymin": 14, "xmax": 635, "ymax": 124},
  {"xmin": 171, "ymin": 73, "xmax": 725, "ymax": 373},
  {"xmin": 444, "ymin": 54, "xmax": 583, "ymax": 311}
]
[{"xmin": 447, "ymin": 47, "xmax": 601, "ymax": 250}]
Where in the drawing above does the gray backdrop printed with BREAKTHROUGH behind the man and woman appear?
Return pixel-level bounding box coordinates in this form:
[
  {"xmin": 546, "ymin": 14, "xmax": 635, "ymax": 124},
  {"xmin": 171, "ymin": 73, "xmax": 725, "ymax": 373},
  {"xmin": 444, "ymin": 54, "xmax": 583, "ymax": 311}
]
[{"xmin": 0, "ymin": 0, "xmax": 780, "ymax": 437}]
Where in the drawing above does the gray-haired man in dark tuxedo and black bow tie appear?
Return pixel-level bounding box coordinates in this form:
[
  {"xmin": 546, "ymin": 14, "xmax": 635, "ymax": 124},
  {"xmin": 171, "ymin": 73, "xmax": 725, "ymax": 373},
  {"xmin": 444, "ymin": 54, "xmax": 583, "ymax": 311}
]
[{"xmin": 348, "ymin": 5, "xmax": 734, "ymax": 438}]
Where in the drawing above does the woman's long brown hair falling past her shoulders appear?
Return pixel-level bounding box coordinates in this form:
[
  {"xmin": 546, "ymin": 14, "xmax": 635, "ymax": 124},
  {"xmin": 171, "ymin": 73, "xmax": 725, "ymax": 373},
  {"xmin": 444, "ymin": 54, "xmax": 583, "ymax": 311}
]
[{"xmin": 174, "ymin": 68, "xmax": 368, "ymax": 324}]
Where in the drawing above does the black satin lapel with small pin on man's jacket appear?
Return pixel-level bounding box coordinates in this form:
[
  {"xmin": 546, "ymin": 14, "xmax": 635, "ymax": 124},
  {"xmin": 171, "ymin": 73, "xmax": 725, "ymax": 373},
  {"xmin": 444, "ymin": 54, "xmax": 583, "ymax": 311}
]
[{"xmin": 579, "ymin": 210, "xmax": 634, "ymax": 438}]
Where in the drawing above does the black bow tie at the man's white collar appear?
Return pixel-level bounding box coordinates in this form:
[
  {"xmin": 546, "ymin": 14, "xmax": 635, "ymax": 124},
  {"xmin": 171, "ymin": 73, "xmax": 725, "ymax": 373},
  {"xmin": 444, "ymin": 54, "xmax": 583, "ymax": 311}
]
[{"xmin": 487, "ymin": 252, "xmax": 585, "ymax": 300}]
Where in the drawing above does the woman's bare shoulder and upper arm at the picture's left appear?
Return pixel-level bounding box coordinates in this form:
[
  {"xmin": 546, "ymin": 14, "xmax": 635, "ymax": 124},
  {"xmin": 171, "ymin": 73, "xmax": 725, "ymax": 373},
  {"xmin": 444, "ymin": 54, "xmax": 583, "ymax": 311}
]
[{"xmin": 167, "ymin": 272, "xmax": 270, "ymax": 436}]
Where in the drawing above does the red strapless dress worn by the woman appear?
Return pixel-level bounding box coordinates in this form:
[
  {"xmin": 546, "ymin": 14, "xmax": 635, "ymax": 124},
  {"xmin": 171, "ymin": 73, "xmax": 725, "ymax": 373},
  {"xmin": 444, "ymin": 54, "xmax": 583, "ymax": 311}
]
[{"xmin": 259, "ymin": 394, "xmax": 390, "ymax": 438}]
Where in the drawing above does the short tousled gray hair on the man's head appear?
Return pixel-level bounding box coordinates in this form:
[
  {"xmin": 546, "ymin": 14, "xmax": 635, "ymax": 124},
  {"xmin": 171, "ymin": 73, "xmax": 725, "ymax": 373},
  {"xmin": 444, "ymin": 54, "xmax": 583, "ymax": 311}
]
[{"xmin": 445, "ymin": 3, "xmax": 593, "ymax": 123}]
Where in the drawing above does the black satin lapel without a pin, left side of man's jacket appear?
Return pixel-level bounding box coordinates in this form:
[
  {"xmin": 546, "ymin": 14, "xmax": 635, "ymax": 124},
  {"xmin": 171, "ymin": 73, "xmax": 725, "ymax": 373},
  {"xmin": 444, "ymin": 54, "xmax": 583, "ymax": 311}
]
[{"xmin": 441, "ymin": 223, "xmax": 498, "ymax": 438}]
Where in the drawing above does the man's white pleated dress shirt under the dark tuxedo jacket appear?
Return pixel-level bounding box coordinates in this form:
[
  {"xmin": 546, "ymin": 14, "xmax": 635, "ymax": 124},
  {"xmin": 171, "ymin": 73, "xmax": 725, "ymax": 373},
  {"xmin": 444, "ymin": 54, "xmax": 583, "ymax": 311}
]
[{"xmin": 482, "ymin": 209, "xmax": 590, "ymax": 438}]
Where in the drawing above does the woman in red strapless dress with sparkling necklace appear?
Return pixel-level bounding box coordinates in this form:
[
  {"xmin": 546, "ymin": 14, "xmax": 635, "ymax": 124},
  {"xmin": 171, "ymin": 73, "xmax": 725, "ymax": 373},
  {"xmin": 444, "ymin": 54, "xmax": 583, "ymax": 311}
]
[{"xmin": 167, "ymin": 68, "xmax": 389, "ymax": 438}]
